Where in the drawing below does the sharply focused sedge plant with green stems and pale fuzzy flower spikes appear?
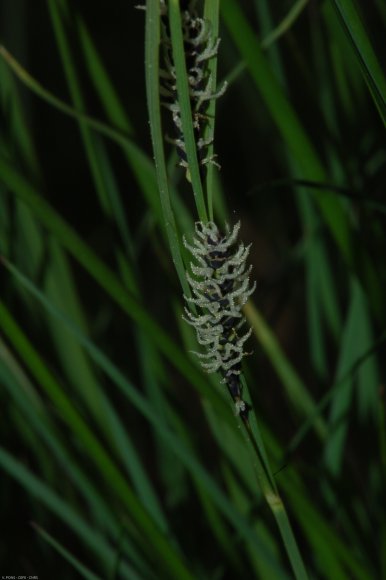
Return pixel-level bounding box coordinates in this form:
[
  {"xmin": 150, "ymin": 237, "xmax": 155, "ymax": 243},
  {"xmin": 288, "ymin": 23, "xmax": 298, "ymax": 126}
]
[{"xmin": 146, "ymin": 0, "xmax": 307, "ymax": 579}]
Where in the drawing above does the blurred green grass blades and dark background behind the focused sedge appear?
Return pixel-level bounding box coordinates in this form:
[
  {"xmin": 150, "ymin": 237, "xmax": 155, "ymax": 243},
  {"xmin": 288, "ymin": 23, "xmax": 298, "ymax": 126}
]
[{"xmin": 0, "ymin": 0, "xmax": 386, "ymax": 580}]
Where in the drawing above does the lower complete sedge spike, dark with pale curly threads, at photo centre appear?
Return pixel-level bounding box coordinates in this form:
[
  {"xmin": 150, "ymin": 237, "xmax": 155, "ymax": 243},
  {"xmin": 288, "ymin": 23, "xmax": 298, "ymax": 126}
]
[{"xmin": 184, "ymin": 222, "xmax": 256, "ymax": 417}]
